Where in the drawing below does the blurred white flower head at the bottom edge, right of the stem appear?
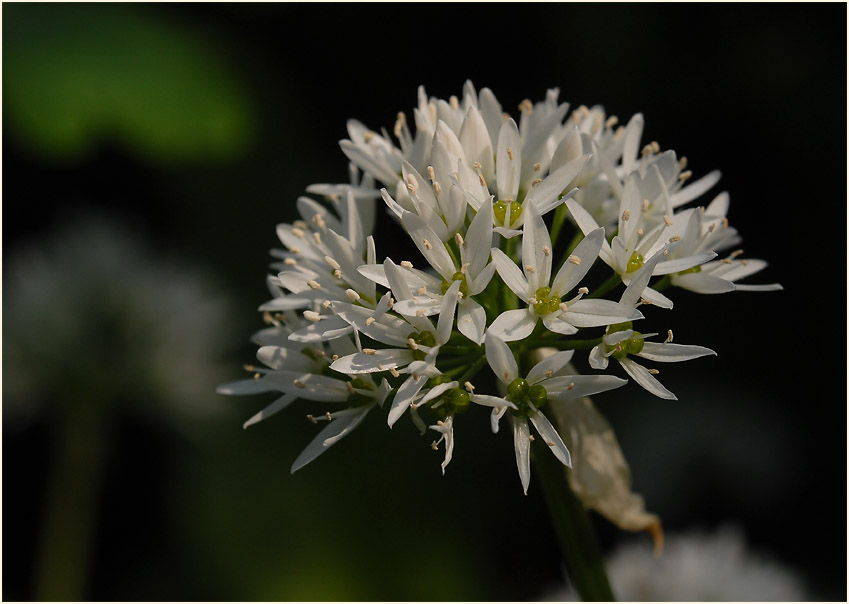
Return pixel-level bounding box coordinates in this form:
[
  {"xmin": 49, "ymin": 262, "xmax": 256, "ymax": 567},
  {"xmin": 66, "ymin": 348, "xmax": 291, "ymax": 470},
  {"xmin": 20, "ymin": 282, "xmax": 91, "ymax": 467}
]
[{"xmin": 543, "ymin": 525, "xmax": 810, "ymax": 602}]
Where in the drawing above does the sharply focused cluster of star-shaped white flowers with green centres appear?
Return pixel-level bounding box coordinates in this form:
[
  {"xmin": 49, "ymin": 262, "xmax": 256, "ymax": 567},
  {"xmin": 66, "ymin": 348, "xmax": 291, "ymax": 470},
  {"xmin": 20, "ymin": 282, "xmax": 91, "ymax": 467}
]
[{"xmin": 219, "ymin": 83, "xmax": 780, "ymax": 492}]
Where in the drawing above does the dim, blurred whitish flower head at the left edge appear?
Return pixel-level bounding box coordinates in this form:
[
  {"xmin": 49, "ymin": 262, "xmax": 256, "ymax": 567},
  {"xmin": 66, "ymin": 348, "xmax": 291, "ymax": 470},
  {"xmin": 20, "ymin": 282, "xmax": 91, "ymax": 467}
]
[{"xmin": 3, "ymin": 212, "xmax": 235, "ymax": 429}]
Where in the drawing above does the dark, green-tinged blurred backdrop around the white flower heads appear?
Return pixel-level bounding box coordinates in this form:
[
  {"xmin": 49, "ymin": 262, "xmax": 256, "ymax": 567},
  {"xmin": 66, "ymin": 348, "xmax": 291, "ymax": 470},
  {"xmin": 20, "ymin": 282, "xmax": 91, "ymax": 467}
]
[{"xmin": 2, "ymin": 3, "xmax": 846, "ymax": 600}]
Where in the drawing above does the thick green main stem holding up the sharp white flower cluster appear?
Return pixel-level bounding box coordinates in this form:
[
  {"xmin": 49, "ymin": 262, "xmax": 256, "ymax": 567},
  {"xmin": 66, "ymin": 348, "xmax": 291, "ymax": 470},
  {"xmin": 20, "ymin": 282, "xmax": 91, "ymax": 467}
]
[{"xmin": 531, "ymin": 438, "xmax": 615, "ymax": 602}]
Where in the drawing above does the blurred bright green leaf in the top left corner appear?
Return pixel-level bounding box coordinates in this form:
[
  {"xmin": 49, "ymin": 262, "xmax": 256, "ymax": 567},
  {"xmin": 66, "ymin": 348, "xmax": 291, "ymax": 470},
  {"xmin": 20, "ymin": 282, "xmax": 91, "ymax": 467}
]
[{"xmin": 3, "ymin": 3, "xmax": 254, "ymax": 163}]
